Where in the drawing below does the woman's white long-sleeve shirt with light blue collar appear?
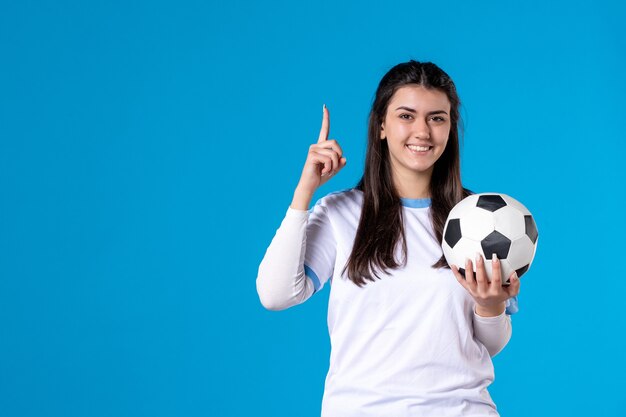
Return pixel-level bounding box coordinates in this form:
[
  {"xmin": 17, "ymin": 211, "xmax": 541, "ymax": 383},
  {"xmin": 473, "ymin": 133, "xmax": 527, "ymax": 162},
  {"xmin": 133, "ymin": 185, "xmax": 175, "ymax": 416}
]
[{"xmin": 256, "ymin": 189, "xmax": 515, "ymax": 417}]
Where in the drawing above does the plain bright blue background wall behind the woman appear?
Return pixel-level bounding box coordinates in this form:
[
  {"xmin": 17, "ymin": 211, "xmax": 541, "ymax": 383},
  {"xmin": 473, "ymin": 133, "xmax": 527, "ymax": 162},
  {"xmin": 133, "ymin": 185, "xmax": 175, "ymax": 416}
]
[{"xmin": 0, "ymin": 0, "xmax": 626, "ymax": 417}]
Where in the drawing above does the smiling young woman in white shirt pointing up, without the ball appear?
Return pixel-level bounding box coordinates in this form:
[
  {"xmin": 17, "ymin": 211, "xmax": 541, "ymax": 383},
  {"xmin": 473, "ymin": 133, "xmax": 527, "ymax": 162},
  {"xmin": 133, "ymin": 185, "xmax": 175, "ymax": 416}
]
[{"xmin": 256, "ymin": 60, "xmax": 520, "ymax": 417}]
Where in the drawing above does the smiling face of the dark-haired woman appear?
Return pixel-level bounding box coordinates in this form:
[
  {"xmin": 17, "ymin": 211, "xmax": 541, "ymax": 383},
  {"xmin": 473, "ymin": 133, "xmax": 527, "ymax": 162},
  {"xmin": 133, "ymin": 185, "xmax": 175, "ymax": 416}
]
[{"xmin": 380, "ymin": 84, "xmax": 450, "ymax": 179}]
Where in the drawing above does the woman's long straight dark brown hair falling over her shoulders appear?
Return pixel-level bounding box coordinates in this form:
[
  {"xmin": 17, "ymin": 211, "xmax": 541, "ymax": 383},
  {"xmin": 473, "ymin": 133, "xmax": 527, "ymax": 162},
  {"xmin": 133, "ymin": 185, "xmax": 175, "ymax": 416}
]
[{"xmin": 342, "ymin": 60, "xmax": 472, "ymax": 286}]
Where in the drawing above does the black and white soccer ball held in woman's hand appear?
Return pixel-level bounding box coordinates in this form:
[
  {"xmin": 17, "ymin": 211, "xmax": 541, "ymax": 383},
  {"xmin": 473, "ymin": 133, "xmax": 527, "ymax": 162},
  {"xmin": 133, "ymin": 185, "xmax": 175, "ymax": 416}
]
[{"xmin": 442, "ymin": 193, "xmax": 539, "ymax": 285}]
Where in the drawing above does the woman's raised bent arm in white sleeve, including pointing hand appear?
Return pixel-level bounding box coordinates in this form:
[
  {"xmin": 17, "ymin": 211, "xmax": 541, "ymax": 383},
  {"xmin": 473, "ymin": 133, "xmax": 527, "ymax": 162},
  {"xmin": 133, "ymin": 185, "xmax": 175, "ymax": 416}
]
[{"xmin": 256, "ymin": 106, "xmax": 346, "ymax": 310}]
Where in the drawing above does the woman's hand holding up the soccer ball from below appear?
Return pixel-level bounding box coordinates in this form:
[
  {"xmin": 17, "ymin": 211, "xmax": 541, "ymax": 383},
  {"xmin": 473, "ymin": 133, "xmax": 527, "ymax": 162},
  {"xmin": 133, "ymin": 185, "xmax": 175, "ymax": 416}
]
[{"xmin": 450, "ymin": 254, "xmax": 520, "ymax": 316}]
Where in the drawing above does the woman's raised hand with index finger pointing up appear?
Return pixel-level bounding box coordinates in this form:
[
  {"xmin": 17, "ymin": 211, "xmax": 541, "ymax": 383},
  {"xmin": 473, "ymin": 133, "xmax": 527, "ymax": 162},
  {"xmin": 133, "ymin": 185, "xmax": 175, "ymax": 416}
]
[{"xmin": 296, "ymin": 105, "xmax": 346, "ymax": 197}]
